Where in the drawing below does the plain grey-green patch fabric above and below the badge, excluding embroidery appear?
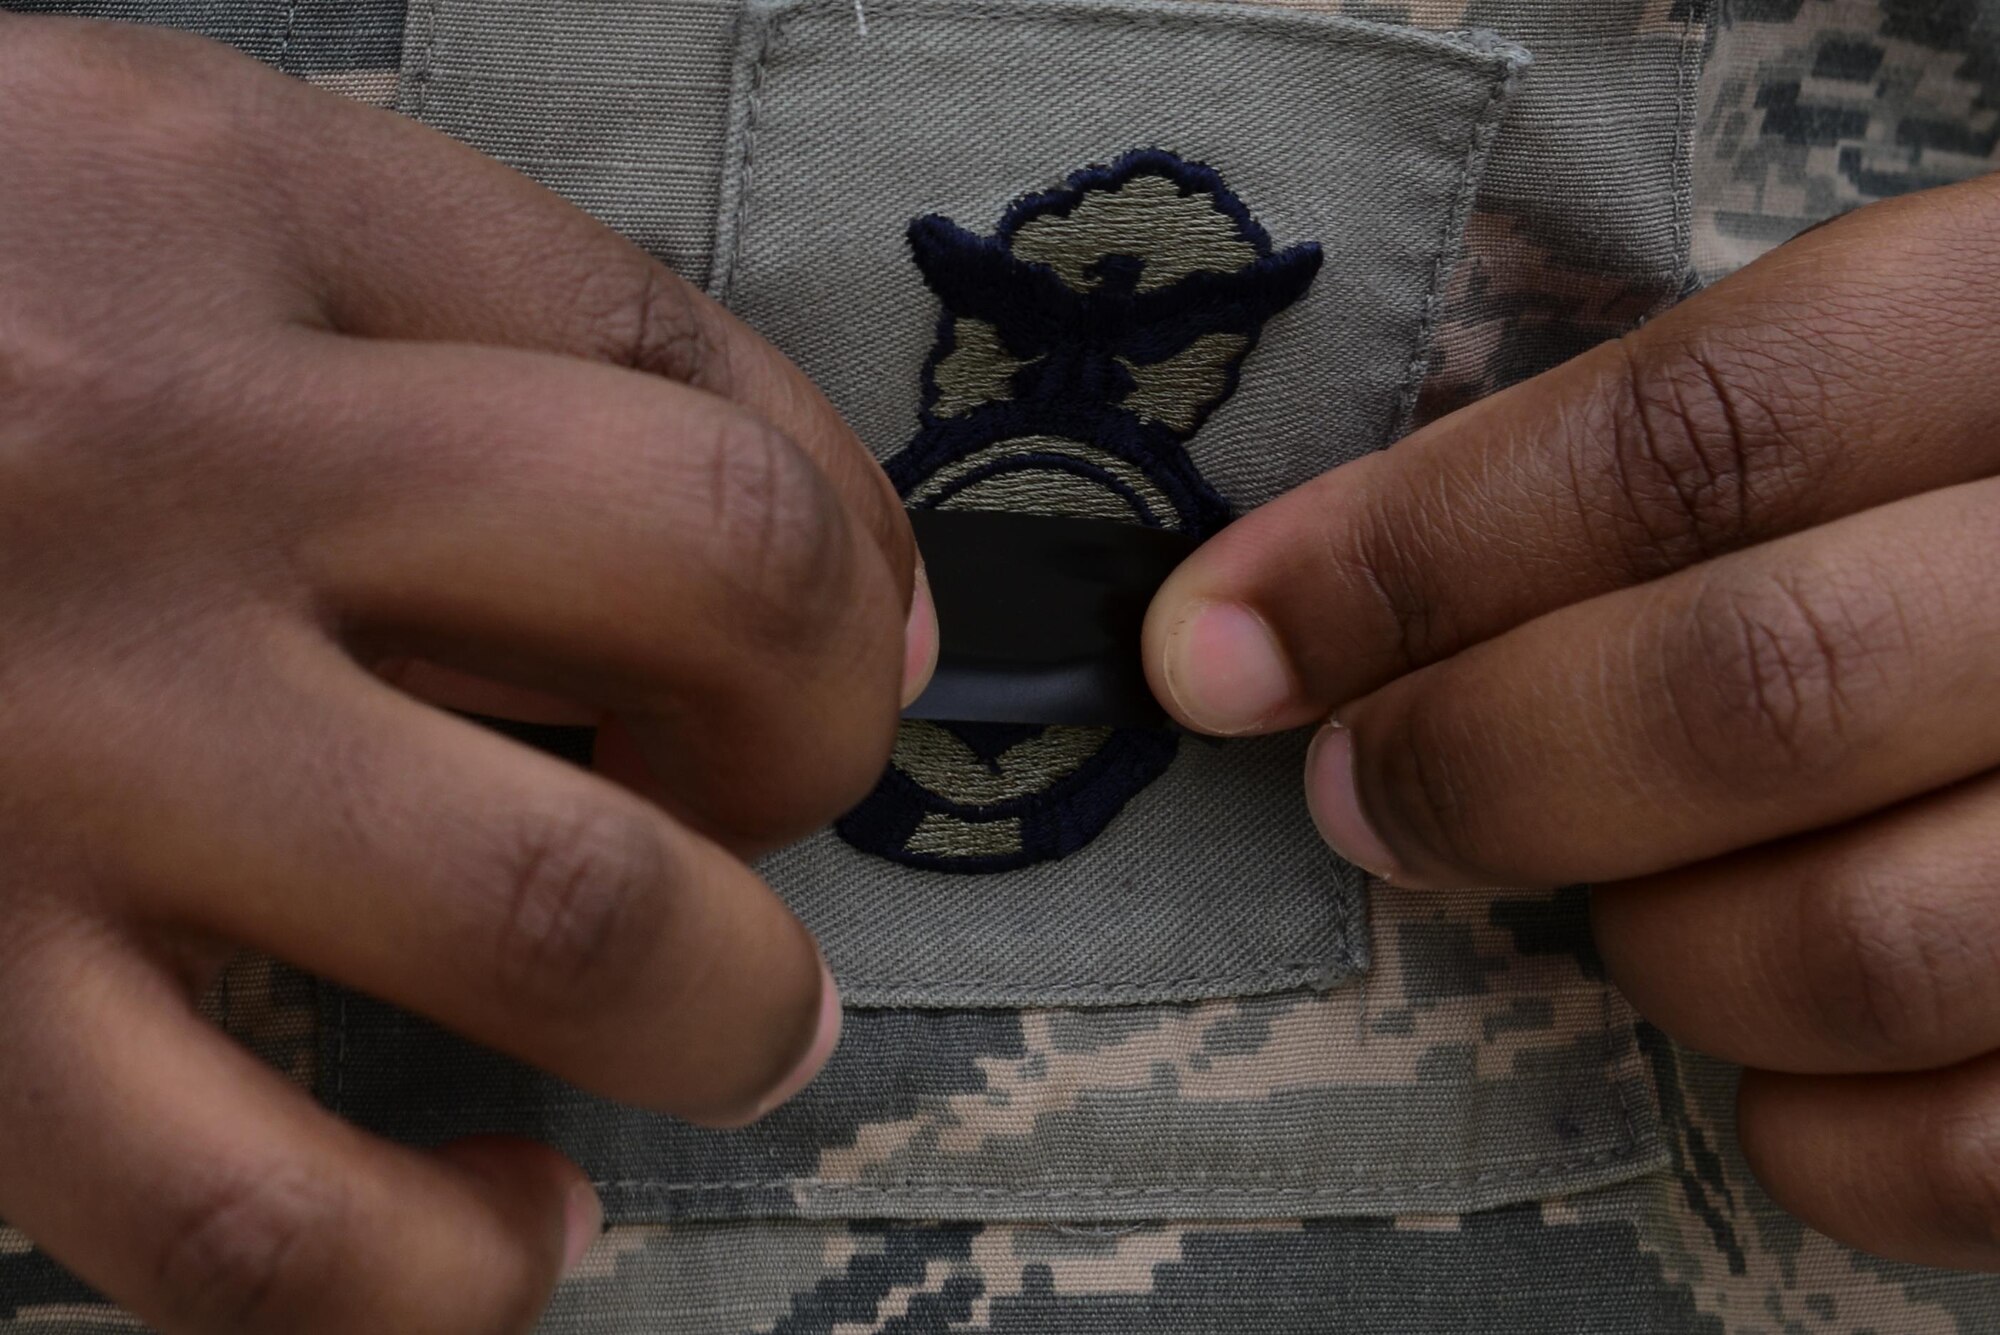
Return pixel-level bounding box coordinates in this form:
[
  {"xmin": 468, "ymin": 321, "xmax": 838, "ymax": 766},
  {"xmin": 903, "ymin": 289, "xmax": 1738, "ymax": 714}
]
[{"xmin": 728, "ymin": 0, "xmax": 1522, "ymax": 1005}]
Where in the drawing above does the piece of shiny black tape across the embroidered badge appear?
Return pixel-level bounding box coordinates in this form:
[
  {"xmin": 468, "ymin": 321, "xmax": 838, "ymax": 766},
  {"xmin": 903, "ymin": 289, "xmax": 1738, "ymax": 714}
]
[{"xmin": 904, "ymin": 510, "xmax": 1198, "ymax": 727}]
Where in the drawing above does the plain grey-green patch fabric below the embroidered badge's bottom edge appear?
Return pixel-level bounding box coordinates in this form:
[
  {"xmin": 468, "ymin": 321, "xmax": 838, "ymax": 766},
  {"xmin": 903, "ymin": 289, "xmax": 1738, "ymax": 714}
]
[{"xmin": 760, "ymin": 737, "xmax": 1368, "ymax": 1005}]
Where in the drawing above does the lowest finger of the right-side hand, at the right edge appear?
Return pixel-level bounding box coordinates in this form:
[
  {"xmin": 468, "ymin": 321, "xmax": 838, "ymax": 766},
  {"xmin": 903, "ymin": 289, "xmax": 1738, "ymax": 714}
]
[{"xmin": 1736, "ymin": 1055, "xmax": 2000, "ymax": 1269}]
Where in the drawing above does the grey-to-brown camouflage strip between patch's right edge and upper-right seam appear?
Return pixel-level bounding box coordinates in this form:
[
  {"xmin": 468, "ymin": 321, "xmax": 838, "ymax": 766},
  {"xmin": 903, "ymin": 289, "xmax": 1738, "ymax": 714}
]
[{"xmin": 1336, "ymin": 0, "xmax": 1714, "ymax": 422}]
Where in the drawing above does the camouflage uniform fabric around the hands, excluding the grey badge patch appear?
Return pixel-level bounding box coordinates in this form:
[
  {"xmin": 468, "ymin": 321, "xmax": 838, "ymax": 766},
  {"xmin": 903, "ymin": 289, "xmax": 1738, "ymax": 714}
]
[{"xmin": 0, "ymin": 0, "xmax": 2000, "ymax": 1335}]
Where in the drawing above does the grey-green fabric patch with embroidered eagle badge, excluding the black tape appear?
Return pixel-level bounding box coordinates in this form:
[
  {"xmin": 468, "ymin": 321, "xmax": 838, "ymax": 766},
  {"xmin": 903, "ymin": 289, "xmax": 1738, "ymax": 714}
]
[{"xmin": 710, "ymin": 0, "xmax": 1526, "ymax": 1005}]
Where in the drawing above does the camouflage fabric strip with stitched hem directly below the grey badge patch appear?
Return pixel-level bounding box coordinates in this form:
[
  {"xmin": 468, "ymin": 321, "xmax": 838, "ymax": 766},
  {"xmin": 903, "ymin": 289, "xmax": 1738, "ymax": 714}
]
[{"xmin": 318, "ymin": 891, "xmax": 1668, "ymax": 1223}]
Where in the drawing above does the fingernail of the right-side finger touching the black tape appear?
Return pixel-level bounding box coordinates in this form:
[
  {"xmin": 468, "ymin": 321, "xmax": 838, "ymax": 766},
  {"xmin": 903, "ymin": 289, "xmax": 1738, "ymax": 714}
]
[{"xmin": 1162, "ymin": 604, "xmax": 1298, "ymax": 735}]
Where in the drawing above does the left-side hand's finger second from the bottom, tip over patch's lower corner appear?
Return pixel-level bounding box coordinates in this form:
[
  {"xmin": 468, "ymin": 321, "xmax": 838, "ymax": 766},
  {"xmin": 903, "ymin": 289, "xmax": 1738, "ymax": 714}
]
[{"xmin": 82, "ymin": 619, "xmax": 840, "ymax": 1125}]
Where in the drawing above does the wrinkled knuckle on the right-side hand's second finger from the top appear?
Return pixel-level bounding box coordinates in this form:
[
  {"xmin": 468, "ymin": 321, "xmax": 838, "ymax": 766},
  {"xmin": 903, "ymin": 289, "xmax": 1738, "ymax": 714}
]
[{"xmin": 1664, "ymin": 576, "xmax": 1908, "ymax": 793}]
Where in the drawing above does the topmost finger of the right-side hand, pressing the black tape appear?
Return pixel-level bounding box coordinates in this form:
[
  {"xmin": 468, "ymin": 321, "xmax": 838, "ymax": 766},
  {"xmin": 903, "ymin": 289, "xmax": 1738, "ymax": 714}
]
[{"xmin": 1146, "ymin": 178, "xmax": 2000, "ymax": 733}]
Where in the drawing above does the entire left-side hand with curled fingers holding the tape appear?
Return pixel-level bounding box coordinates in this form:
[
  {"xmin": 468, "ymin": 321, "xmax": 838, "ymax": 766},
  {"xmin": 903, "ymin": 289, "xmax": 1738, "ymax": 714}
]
[{"xmin": 0, "ymin": 16, "xmax": 936, "ymax": 1333}]
